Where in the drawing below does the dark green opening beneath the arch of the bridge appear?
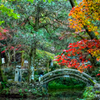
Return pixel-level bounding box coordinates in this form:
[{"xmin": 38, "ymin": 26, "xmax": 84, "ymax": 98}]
[{"xmin": 47, "ymin": 77, "xmax": 87, "ymax": 90}]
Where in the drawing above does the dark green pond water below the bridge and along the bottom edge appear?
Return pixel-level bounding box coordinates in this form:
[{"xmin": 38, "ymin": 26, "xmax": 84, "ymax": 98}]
[{"xmin": 0, "ymin": 89, "xmax": 84, "ymax": 100}]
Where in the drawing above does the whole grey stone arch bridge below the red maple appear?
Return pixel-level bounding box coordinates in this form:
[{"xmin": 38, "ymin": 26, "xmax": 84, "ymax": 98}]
[{"xmin": 39, "ymin": 68, "xmax": 97, "ymax": 86}]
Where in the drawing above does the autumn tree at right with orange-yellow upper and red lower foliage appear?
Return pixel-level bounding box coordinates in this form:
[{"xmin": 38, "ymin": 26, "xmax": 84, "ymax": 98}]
[{"xmin": 56, "ymin": 0, "xmax": 100, "ymax": 71}]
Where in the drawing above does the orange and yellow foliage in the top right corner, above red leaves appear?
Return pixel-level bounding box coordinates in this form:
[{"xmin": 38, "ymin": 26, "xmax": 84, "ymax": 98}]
[{"xmin": 69, "ymin": 0, "xmax": 100, "ymax": 35}]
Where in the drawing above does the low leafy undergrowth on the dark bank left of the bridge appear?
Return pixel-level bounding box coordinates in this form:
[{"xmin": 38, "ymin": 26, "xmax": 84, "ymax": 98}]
[{"xmin": 0, "ymin": 83, "xmax": 46, "ymax": 98}]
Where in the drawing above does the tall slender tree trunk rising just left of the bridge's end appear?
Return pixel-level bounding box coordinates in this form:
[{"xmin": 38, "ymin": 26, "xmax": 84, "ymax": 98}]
[{"xmin": 28, "ymin": 3, "xmax": 40, "ymax": 82}]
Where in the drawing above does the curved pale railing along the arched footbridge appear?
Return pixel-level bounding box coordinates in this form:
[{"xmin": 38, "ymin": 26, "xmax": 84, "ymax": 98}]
[{"xmin": 39, "ymin": 68, "xmax": 96, "ymax": 85}]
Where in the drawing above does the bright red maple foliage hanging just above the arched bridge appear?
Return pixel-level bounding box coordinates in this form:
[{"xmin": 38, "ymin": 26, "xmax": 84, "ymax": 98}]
[{"xmin": 54, "ymin": 39, "xmax": 100, "ymax": 71}]
